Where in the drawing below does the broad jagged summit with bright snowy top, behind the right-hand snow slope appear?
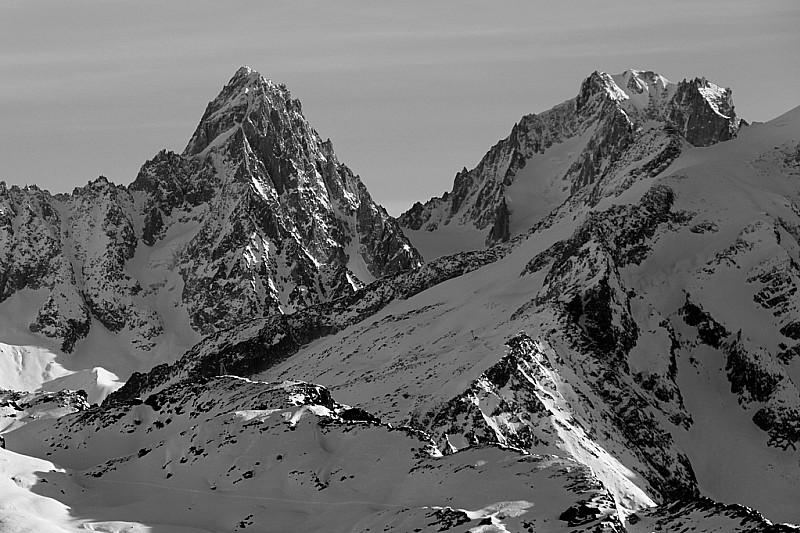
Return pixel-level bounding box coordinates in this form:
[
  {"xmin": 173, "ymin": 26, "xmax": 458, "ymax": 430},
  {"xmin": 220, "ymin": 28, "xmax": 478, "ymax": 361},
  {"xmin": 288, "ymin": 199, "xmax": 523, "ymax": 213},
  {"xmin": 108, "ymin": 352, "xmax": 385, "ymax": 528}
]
[{"xmin": 399, "ymin": 70, "xmax": 739, "ymax": 244}]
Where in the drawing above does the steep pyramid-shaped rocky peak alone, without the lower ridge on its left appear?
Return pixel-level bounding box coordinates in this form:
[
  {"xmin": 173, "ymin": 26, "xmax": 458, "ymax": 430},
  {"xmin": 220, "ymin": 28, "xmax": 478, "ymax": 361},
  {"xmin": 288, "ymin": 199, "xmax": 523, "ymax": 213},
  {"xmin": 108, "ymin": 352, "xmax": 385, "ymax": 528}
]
[{"xmin": 172, "ymin": 66, "xmax": 419, "ymax": 332}]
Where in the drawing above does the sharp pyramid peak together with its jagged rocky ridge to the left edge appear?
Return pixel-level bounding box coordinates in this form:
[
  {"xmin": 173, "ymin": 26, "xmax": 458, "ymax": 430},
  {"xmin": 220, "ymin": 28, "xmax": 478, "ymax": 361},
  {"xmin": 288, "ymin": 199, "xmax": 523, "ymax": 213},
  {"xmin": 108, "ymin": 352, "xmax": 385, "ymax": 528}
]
[{"xmin": 0, "ymin": 67, "xmax": 420, "ymax": 352}]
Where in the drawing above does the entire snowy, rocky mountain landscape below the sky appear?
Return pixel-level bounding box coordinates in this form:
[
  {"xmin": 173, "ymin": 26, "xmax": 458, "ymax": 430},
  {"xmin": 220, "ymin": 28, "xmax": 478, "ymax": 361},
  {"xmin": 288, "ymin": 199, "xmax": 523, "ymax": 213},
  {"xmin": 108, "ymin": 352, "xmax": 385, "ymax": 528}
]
[{"xmin": 0, "ymin": 68, "xmax": 800, "ymax": 533}]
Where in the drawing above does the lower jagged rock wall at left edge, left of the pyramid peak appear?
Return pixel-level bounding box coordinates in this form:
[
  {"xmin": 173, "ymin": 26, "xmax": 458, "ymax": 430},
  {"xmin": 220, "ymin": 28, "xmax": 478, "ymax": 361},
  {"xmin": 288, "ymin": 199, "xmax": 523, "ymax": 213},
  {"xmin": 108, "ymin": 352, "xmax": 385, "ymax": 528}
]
[{"xmin": 0, "ymin": 177, "xmax": 162, "ymax": 352}]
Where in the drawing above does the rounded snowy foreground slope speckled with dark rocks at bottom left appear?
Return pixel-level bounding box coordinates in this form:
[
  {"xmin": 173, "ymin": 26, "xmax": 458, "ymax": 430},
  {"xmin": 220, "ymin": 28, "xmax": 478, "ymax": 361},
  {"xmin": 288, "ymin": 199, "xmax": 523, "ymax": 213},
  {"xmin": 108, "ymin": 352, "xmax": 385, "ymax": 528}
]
[{"xmin": 8, "ymin": 376, "xmax": 628, "ymax": 532}]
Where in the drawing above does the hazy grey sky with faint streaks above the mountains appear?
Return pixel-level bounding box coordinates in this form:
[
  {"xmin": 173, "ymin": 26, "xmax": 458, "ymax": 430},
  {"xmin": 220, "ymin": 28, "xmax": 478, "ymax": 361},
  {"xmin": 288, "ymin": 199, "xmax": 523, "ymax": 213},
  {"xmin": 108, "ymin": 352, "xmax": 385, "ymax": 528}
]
[{"xmin": 0, "ymin": 0, "xmax": 800, "ymax": 215}]
